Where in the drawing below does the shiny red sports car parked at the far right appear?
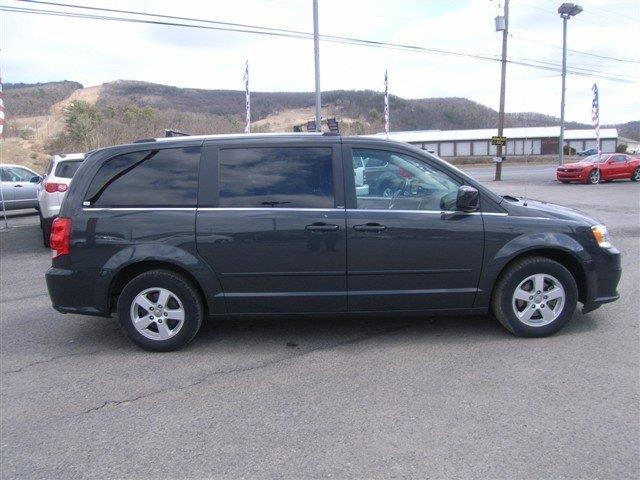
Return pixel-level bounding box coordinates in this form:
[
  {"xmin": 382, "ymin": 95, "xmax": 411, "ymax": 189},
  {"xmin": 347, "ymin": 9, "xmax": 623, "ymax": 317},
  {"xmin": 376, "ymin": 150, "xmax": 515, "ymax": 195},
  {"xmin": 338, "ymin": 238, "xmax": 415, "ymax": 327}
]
[{"xmin": 556, "ymin": 153, "xmax": 640, "ymax": 184}]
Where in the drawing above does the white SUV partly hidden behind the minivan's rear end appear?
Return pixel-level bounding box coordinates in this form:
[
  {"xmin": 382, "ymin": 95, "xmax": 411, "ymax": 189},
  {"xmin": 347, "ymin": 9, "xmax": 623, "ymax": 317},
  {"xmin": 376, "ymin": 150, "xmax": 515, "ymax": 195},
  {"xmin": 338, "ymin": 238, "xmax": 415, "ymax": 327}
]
[{"xmin": 37, "ymin": 153, "xmax": 84, "ymax": 247}]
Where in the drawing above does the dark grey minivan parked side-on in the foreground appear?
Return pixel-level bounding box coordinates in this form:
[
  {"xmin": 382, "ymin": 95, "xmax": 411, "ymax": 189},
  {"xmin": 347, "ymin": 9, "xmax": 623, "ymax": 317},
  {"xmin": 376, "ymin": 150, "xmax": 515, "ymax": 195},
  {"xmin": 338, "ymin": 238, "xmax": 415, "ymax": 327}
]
[{"xmin": 46, "ymin": 133, "xmax": 621, "ymax": 350}]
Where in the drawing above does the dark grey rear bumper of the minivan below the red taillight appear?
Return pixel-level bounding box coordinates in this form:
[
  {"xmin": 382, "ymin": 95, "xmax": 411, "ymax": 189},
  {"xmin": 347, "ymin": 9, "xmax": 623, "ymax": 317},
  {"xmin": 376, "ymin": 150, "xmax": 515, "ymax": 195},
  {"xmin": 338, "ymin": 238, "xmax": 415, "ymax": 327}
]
[{"xmin": 45, "ymin": 267, "xmax": 110, "ymax": 317}]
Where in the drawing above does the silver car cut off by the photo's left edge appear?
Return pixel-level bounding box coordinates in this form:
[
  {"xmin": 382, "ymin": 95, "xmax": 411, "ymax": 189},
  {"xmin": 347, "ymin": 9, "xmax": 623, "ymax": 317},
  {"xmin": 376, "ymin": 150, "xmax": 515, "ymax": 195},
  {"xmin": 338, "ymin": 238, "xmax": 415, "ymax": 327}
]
[{"xmin": 0, "ymin": 164, "xmax": 41, "ymax": 211}]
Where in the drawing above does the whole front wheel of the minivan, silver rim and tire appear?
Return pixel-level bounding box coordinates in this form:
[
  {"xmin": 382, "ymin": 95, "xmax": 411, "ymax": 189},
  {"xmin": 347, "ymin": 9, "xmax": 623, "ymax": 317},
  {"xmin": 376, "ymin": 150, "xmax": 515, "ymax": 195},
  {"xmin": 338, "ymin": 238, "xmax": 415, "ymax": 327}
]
[{"xmin": 492, "ymin": 257, "xmax": 578, "ymax": 337}]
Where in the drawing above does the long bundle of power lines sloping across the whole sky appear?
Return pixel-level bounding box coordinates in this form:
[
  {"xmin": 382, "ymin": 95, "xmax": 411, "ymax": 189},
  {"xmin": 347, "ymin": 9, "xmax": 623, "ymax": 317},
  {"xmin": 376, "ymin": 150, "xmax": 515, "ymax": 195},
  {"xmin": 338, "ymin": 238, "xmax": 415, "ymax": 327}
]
[{"xmin": 0, "ymin": 0, "xmax": 635, "ymax": 83}]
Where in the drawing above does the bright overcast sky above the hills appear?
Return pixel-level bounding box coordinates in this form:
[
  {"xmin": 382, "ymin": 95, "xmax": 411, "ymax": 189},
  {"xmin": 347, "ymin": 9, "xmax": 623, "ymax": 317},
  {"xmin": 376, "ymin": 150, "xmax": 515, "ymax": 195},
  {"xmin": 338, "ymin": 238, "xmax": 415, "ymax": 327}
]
[{"xmin": 0, "ymin": 0, "xmax": 640, "ymax": 123}]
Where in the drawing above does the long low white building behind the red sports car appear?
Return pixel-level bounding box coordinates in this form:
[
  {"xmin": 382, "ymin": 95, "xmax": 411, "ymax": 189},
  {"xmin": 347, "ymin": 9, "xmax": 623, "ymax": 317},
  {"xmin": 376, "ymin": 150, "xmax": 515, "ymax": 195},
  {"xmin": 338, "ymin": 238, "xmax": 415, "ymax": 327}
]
[{"xmin": 375, "ymin": 126, "xmax": 618, "ymax": 157}]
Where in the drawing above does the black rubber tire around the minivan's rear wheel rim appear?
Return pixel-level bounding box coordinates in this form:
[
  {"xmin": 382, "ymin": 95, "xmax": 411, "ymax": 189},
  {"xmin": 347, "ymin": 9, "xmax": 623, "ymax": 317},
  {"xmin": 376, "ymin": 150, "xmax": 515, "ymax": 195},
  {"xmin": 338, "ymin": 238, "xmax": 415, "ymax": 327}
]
[{"xmin": 118, "ymin": 270, "xmax": 203, "ymax": 352}]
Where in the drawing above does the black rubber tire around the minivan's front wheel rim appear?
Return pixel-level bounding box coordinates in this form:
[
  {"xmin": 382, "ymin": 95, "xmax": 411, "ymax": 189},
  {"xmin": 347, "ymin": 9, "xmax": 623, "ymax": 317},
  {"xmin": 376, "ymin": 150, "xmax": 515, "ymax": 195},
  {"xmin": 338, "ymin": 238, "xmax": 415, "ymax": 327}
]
[{"xmin": 491, "ymin": 256, "xmax": 578, "ymax": 337}]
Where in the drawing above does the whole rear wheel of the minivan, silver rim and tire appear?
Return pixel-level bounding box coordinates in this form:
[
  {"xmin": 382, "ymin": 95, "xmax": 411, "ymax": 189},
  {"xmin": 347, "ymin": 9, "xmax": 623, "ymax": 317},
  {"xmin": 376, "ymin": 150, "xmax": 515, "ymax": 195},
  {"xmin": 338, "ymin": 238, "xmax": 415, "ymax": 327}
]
[{"xmin": 118, "ymin": 270, "xmax": 203, "ymax": 352}]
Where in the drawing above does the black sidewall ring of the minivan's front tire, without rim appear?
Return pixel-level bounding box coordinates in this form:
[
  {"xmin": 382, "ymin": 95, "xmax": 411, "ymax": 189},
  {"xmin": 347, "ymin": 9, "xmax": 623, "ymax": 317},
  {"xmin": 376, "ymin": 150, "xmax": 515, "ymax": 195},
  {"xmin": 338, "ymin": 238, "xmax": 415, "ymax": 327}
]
[{"xmin": 499, "ymin": 259, "xmax": 578, "ymax": 337}]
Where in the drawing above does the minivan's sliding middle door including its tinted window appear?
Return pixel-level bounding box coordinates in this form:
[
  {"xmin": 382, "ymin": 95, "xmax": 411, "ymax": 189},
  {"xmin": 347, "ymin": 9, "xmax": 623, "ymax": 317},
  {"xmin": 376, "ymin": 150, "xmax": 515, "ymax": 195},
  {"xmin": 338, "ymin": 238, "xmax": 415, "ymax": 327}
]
[{"xmin": 196, "ymin": 138, "xmax": 347, "ymax": 313}]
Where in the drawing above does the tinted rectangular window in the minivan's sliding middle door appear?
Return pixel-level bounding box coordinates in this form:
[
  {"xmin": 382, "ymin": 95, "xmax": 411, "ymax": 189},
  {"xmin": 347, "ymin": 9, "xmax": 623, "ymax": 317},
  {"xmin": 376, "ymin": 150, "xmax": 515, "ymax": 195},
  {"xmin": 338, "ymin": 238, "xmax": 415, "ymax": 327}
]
[{"xmin": 219, "ymin": 147, "xmax": 334, "ymax": 208}]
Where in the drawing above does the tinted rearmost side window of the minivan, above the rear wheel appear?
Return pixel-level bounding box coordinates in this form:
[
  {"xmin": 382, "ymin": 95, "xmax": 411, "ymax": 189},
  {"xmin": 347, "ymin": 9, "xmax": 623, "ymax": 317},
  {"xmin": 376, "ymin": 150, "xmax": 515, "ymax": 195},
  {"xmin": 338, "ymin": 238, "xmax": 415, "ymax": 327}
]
[{"xmin": 85, "ymin": 147, "xmax": 201, "ymax": 207}]
